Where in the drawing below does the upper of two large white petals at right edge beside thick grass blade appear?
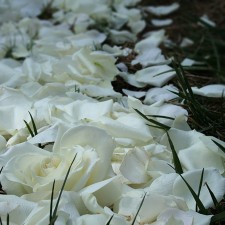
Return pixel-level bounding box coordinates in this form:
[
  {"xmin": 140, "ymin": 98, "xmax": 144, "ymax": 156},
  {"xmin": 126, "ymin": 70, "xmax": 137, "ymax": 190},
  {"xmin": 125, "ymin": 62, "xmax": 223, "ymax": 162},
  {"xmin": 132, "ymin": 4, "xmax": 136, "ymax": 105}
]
[{"xmin": 160, "ymin": 128, "xmax": 224, "ymax": 174}]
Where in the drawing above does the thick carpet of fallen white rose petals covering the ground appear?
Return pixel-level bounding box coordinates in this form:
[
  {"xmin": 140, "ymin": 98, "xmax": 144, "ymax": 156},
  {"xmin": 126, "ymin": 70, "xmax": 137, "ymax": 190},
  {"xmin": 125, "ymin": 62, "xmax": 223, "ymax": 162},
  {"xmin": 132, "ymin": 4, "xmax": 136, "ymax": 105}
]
[{"xmin": 0, "ymin": 0, "xmax": 225, "ymax": 225}]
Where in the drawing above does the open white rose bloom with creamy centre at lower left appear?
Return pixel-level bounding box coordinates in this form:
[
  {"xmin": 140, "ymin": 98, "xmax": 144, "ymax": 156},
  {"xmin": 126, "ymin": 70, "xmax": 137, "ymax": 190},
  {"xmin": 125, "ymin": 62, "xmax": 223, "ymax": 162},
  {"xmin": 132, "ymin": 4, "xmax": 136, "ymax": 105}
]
[{"xmin": 0, "ymin": 126, "xmax": 114, "ymax": 200}]
